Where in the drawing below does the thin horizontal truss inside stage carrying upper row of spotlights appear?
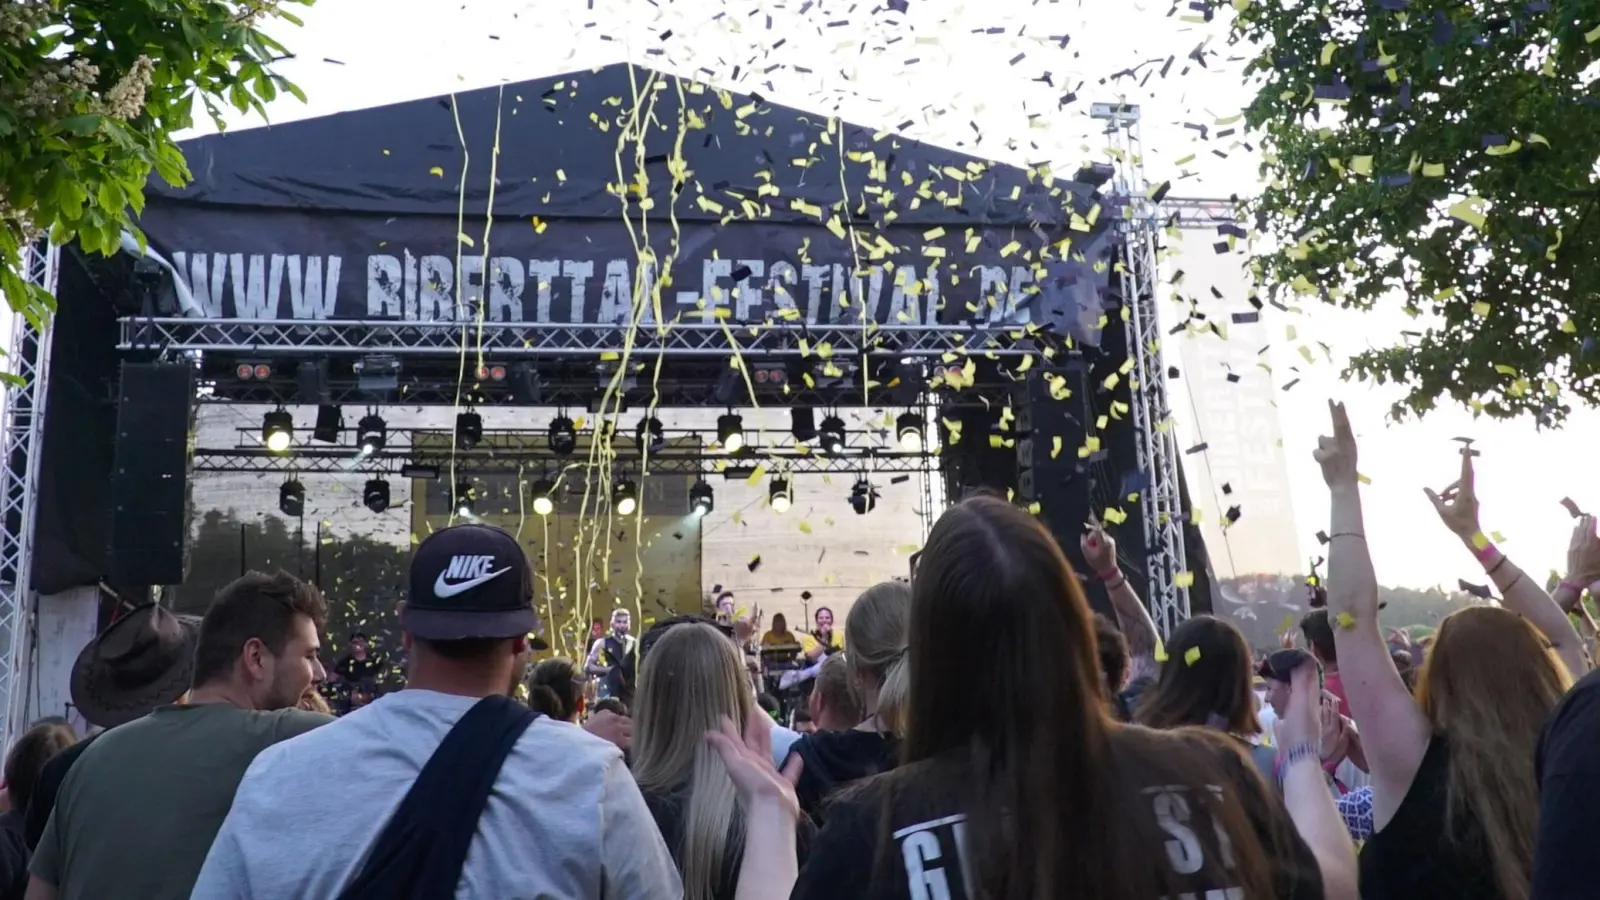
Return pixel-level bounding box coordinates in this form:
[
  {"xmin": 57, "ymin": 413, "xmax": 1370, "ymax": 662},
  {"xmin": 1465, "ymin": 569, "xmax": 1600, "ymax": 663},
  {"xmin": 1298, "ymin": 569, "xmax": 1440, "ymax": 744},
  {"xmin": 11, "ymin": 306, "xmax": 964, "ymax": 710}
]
[{"xmin": 194, "ymin": 447, "xmax": 936, "ymax": 477}]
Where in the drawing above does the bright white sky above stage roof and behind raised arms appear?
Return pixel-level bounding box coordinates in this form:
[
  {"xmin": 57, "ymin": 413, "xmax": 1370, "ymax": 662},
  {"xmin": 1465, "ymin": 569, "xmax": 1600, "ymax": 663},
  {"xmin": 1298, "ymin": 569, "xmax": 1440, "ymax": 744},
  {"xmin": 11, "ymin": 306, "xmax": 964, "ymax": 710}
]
[{"xmin": 34, "ymin": 0, "xmax": 1600, "ymax": 586}]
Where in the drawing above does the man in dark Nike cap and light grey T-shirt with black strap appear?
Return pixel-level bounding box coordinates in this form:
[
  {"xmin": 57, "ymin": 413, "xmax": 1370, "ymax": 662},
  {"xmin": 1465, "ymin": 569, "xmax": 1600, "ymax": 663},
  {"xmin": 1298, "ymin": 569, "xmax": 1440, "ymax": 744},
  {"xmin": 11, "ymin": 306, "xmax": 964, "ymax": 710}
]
[{"xmin": 194, "ymin": 524, "xmax": 678, "ymax": 900}]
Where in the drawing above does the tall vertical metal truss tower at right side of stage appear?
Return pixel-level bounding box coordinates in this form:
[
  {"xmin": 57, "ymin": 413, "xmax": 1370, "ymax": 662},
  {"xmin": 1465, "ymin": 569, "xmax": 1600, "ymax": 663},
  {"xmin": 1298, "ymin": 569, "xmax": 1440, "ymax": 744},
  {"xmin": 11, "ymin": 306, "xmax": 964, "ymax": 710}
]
[{"xmin": 1093, "ymin": 104, "xmax": 1205, "ymax": 636}]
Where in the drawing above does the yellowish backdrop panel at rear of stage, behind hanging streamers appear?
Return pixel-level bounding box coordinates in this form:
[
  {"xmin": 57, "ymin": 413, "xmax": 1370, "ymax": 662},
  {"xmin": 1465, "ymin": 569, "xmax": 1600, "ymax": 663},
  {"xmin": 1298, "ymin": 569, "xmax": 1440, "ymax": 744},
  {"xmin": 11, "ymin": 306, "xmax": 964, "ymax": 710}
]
[{"xmin": 411, "ymin": 432, "xmax": 704, "ymax": 657}]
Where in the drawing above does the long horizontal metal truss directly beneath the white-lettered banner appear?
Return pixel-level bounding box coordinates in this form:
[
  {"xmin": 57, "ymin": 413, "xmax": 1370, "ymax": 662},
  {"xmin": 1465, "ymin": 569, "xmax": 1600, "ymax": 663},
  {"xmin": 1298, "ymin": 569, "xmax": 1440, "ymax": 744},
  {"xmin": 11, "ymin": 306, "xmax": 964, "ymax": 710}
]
[{"xmin": 117, "ymin": 317, "xmax": 1038, "ymax": 359}]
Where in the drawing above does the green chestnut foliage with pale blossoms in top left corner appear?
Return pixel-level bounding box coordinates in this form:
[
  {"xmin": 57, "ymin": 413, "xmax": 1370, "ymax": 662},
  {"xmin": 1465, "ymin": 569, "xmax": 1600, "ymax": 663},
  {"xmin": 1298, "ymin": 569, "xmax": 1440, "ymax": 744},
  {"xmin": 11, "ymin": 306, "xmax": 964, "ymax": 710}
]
[{"xmin": 0, "ymin": 0, "xmax": 312, "ymax": 336}]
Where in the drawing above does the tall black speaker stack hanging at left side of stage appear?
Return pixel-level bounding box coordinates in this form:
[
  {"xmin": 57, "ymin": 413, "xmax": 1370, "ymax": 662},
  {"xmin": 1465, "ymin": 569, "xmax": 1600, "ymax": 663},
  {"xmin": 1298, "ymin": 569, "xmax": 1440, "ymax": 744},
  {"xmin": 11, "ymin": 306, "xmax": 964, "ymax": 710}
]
[{"xmin": 109, "ymin": 364, "xmax": 195, "ymax": 586}]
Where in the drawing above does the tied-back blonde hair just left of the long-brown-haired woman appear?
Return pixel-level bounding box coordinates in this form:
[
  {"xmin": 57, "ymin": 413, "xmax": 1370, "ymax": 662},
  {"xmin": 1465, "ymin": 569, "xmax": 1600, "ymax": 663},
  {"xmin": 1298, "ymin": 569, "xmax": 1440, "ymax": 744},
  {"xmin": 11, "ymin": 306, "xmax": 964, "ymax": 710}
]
[{"xmin": 845, "ymin": 581, "xmax": 910, "ymax": 735}]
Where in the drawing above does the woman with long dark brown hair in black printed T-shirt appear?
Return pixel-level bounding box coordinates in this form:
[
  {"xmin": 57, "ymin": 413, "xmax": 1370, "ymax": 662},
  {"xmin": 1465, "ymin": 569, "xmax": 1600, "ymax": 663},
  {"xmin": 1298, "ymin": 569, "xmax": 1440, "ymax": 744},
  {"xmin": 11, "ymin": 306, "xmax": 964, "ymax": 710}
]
[{"xmin": 794, "ymin": 496, "xmax": 1355, "ymax": 900}]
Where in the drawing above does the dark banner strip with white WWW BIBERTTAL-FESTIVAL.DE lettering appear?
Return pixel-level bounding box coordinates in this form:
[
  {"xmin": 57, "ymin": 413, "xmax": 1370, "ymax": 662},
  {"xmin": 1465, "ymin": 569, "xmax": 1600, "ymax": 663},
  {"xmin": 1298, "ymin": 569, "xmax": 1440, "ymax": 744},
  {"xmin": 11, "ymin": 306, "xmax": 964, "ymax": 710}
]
[{"xmin": 139, "ymin": 199, "xmax": 1115, "ymax": 344}]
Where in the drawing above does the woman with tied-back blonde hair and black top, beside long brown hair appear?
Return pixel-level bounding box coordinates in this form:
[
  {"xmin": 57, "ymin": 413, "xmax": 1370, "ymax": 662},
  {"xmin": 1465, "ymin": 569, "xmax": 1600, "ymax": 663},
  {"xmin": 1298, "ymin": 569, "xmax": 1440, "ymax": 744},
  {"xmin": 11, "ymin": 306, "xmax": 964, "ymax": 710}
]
[{"xmin": 790, "ymin": 581, "xmax": 910, "ymax": 820}]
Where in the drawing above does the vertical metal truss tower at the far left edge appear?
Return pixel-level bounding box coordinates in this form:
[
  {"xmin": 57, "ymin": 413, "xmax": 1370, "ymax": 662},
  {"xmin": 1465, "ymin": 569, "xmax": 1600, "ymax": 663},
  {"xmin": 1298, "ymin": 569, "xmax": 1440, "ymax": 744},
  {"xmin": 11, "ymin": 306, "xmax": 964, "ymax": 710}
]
[{"xmin": 0, "ymin": 245, "xmax": 61, "ymax": 746}]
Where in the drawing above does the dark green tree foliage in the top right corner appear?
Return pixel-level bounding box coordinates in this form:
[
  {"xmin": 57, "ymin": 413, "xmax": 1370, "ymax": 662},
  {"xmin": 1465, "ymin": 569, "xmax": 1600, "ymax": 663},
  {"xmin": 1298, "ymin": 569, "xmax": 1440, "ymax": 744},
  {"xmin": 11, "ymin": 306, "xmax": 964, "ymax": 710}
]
[{"xmin": 1218, "ymin": 0, "xmax": 1600, "ymax": 424}]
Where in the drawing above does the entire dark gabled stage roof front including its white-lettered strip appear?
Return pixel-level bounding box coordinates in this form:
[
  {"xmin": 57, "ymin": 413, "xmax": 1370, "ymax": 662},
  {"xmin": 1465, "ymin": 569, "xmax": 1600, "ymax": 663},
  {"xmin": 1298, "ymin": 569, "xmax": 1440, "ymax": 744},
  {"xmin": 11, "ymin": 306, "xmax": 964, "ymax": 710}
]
[{"xmin": 139, "ymin": 64, "xmax": 1118, "ymax": 343}]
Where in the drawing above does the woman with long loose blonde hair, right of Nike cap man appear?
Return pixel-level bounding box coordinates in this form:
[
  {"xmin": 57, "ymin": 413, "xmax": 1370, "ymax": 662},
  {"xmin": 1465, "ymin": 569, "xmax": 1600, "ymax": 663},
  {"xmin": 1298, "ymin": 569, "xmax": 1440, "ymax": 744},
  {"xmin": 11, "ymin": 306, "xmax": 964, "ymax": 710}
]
[{"xmin": 634, "ymin": 623, "xmax": 812, "ymax": 900}]
